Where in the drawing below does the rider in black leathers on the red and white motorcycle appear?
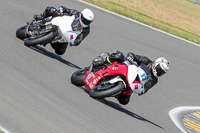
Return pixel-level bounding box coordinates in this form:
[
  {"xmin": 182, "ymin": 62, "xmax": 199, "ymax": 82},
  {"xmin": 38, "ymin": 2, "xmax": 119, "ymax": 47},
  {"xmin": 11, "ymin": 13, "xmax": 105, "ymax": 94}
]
[{"xmin": 93, "ymin": 51, "xmax": 169, "ymax": 105}]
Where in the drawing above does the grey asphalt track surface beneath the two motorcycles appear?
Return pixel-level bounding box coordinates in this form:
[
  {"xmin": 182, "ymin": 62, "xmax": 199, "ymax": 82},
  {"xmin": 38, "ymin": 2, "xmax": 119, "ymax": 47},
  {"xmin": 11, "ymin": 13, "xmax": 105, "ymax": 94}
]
[{"xmin": 0, "ymin": 0, "xmax": 200, "ymax": 133}]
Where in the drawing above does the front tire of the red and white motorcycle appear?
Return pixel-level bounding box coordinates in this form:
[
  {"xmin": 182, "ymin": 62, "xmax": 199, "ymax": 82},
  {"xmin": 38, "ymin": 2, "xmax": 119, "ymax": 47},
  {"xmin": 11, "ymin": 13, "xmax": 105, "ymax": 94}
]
[{"xmin": 89, "ymin": 81, "xmax": 125, "ymax": 99}]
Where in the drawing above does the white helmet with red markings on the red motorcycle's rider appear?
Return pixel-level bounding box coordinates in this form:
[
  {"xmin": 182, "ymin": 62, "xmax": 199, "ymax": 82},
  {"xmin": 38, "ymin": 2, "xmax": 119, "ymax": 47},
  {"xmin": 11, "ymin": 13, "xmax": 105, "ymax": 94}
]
[{"xmin": 152, "ymin": 57, "xmax": 169, "ymax": 77}]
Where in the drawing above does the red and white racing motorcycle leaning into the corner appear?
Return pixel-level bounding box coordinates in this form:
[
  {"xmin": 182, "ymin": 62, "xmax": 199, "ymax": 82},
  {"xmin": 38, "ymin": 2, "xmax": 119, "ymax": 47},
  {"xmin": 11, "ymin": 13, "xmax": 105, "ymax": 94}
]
[{"xmin": 71, "ymin": 60, "xmax": 151, "ymax": 99}]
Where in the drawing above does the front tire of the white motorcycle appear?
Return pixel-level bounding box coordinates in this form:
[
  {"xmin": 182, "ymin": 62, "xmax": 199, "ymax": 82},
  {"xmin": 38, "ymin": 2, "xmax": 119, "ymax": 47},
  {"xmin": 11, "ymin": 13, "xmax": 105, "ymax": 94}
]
[{"xmin": 24, "ymin": 32, "xmax": 55, "ymax": 47}]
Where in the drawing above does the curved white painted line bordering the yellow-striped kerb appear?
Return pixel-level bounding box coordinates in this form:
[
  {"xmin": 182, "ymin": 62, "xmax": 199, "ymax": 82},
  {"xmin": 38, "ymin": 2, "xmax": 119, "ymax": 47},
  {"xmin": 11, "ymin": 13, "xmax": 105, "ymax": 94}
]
[{"xmin": 169, "ymin": 106, "xmax": 200, "ymax": 133}]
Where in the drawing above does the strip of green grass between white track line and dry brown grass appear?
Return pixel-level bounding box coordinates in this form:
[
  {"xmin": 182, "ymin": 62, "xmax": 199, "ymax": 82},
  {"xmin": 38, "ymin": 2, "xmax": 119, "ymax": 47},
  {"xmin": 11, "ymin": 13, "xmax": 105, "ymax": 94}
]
[{"xmin": 84, "ymin": 0, "xmax": 200, "ymax": 44}]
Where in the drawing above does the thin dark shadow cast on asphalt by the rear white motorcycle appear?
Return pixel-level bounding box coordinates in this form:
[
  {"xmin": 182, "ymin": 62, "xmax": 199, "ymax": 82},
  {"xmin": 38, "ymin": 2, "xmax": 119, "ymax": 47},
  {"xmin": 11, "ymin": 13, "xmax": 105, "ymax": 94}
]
[{"xmin": 29, "ymin": 46, "xmax": 81, "ymax": 69}]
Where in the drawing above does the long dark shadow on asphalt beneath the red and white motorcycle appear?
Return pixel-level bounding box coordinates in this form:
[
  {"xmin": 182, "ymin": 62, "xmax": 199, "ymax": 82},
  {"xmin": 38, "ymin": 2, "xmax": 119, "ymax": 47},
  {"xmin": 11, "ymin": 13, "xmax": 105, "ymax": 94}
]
[{"xmin": 79, "ymin": 87, "xmax": 164, "ymax": 129}]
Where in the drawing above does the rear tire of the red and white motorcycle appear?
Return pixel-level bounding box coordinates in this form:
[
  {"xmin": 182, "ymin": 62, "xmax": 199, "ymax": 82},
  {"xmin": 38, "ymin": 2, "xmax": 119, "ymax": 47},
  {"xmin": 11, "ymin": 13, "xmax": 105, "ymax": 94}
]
[{"xmin": 71, "ymin": 69, "xmax": 86, "ymax": 86}]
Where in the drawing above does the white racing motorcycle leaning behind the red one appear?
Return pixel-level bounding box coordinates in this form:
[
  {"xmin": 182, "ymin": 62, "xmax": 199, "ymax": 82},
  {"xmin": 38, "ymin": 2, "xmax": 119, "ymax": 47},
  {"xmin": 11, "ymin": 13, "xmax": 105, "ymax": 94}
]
[{"xmin": 16, "ymin": 15, "xmax": 81, "ymax": 46}]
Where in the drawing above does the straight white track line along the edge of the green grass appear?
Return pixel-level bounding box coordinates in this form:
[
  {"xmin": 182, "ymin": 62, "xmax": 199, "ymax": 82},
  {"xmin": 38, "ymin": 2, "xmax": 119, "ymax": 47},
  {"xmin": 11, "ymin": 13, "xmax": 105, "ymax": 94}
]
[{"xmin": 78, "ymin": 0, "xmax": 200, "ymax": 47}]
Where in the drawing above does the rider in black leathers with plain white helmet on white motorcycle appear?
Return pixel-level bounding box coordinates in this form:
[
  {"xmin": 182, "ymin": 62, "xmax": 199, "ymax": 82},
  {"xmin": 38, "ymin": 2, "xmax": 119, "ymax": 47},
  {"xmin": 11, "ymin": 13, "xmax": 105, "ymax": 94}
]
[{"xmin": 34, "ymin": 6, "xmax": 94, "ymax": 55}]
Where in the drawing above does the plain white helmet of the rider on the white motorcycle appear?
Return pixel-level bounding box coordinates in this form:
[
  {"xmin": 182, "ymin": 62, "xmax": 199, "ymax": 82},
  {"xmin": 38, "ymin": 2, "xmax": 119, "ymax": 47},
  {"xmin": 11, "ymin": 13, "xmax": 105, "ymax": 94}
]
[{"xmin": 79, "ymin": 8, "xmax": 94, "ymax": 28}]
